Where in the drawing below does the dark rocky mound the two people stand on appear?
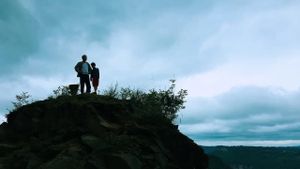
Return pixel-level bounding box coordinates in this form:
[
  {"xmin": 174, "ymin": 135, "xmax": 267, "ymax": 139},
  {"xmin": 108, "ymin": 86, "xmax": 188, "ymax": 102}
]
[{"xmin": 0, "ymin": 95, "xmax": 208, "ymax": 169}]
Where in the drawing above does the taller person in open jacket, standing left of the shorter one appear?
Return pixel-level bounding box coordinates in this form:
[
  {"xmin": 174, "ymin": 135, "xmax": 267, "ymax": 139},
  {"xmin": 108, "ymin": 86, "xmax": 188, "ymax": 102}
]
[{"xmin": 75, "ymin": 55, "xmax": 92, "ymax": 94}]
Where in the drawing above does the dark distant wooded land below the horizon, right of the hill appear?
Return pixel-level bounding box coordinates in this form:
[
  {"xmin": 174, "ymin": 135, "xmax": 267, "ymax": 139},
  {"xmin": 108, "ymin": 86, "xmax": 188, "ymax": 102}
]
[{"xmin": 203, "ymin": 146, "xmax": 300, "ymax": 169}]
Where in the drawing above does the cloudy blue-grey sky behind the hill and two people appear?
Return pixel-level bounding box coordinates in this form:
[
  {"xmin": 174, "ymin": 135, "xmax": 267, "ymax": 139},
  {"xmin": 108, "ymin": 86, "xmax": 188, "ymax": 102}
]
[{"xmin": 0, "ymin": 0, "xmax": 300, "ymax": 146}]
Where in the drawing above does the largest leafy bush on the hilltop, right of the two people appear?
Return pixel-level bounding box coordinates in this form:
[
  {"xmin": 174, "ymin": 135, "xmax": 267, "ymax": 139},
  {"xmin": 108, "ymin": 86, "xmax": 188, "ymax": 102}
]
[{"xmin": 104, "ymin": 80, "xmax": 187, "ymax": 121}]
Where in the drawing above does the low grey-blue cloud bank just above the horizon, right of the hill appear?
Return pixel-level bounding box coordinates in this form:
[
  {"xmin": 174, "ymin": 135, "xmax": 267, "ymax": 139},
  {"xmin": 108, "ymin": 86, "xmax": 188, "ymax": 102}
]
[{"xmin": 180, "ymin": 87, "xmax": 300, "ymax": 144}]
